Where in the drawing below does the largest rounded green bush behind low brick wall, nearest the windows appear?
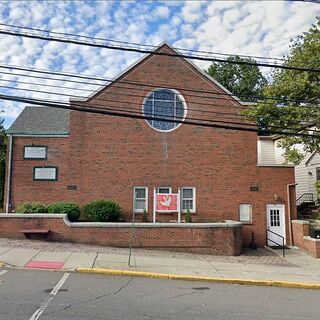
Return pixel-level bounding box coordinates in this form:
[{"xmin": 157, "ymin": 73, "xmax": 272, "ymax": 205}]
[{"xmin": 83, "ymin": 200, "xmax": 121, "ymax": 222}]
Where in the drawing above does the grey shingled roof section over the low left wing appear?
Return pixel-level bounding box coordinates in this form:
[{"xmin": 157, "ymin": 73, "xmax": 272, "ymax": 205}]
[{"xmin": 6, "ymin": 106, "xmax": 70, "ymax": 135}]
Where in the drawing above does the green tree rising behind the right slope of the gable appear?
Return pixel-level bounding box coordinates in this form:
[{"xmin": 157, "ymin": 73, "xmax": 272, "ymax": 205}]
[{"xmin": 207, "ymin": 56, "xmax": 267, "ymax": 101}]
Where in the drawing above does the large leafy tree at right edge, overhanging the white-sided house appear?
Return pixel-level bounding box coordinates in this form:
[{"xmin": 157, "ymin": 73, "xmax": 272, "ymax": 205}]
[{"xmin": 246, "ymin": 17, "xmax": 320, "ymax": 164}]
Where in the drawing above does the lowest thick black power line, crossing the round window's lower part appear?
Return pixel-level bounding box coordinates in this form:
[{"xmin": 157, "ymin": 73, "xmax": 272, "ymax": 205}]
[{"xmin": 0, "ymin": 94, "xmax": 319, "ymax": 137}]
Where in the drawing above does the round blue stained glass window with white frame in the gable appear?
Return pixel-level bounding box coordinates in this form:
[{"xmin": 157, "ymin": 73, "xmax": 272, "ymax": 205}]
[{"xmin": 143, "ymin": 89, "xmax": 187, "ymax": 132}]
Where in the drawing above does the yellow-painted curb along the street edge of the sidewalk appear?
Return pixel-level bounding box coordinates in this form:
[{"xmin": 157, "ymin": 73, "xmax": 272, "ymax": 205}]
[{"xmin": 75, "ymin": 268, "xmax": 320, "ymax": 290}]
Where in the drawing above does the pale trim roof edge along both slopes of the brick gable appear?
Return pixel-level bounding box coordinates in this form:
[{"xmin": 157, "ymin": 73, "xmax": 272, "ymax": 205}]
[{"xmin": 70, "ymin": 41, "xmax": 255, "ymax": 106}]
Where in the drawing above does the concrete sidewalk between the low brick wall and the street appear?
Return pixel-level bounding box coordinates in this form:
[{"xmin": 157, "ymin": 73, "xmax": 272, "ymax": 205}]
[{"xmin": 0, "ymin": 239, "xmax": 320, "ymax": 284}]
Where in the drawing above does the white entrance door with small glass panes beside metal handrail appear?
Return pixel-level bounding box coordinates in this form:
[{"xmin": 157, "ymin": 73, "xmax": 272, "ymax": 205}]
[{"xmin": 267, "ymin": 204, "xmax": 286, "ymax": 246}]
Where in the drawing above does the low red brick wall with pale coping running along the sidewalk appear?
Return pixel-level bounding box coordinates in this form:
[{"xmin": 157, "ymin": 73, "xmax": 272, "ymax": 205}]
[{"xmin": 0, "ymin": 217, "xmax": 242, "ymax": 255}]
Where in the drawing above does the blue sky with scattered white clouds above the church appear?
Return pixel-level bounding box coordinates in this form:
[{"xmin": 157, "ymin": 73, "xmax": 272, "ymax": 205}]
[{"xmin": 0, "ymin": 0, "xmax": 320, "ymax": 127}]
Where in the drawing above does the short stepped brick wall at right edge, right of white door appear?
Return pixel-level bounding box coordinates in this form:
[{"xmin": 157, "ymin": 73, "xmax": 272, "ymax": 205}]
[{"xmin": 292, "ymin": 220, "xmax": 320, "ymax": 258}]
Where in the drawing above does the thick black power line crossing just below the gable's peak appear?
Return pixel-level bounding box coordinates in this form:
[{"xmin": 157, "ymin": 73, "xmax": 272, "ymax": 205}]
[{"xmin": 0, "ymin": 30, "xmax": 320, "ymax": 73}]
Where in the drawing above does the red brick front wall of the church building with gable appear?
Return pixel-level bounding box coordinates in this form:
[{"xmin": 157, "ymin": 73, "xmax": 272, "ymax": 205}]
[{"xmin": 5, "ymin": 44, "xmax": 294, "ymax": 246}]
